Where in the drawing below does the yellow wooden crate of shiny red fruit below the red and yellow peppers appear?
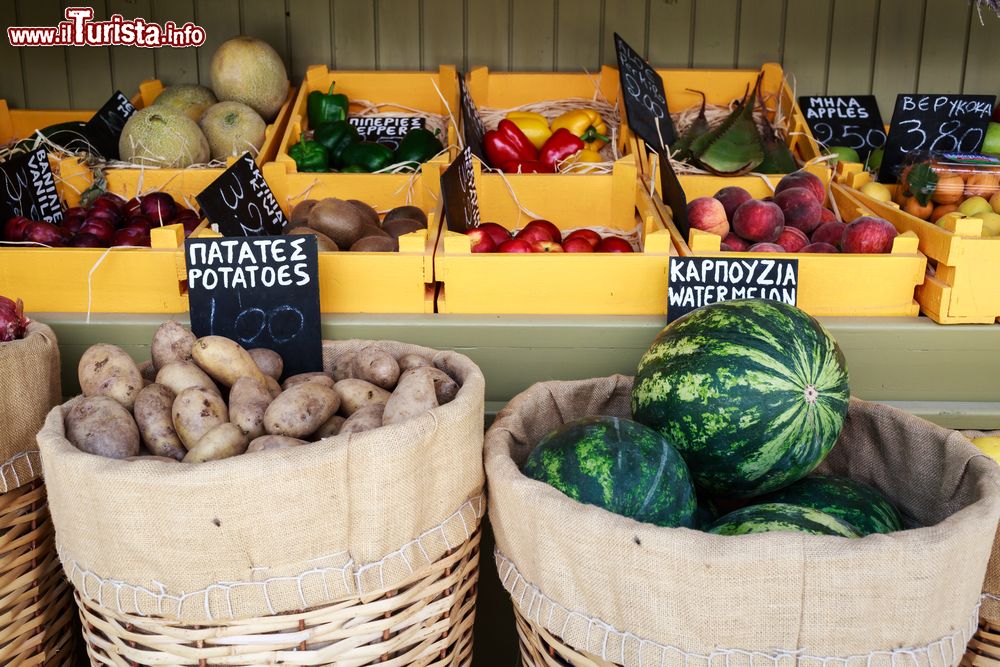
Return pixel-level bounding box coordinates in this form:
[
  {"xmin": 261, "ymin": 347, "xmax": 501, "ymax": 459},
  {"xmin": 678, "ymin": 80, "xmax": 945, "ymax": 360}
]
[{"xmin": 434, "ymin": 158, "xmax": 676, "ymax": 315}]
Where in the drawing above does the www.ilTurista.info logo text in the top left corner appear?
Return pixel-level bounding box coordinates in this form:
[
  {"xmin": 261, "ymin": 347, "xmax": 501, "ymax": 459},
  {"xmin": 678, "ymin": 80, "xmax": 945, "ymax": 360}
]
[{"xmin": 7, "ymin": 7, "xmax": 205, "ymax": 49}]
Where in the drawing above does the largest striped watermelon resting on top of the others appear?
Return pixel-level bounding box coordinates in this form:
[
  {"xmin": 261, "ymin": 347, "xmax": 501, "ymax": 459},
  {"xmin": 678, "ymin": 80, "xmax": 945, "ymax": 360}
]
[{"xmin": 632, "ymin": 300, "xmax": 850, "ymax": 498}]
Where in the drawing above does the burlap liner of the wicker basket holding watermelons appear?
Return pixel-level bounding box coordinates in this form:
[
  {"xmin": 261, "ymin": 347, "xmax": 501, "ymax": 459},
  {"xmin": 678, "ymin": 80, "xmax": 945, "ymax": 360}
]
[{"xmin": 485, "ymin": 376, "xmax": 1000, "ymax": 667}]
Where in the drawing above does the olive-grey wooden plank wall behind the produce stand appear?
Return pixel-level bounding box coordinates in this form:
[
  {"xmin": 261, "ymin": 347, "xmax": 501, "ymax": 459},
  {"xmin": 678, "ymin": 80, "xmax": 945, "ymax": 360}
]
[{"xmin": 0, "ymin": 0, "xmax": 1000, "ymax": 115}]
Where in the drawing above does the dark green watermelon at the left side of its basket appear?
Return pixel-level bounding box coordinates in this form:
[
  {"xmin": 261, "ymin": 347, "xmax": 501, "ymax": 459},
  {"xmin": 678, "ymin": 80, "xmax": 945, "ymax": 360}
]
[{"xmin": 524, "ymin": 417, "xmax": 697, "ymax": 528}]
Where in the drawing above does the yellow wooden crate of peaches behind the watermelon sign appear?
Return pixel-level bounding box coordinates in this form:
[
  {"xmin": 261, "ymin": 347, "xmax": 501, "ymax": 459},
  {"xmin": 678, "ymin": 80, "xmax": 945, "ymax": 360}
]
[{"xmin": 654, "ymin": 176, "xmax": 927, "ymax": 317}]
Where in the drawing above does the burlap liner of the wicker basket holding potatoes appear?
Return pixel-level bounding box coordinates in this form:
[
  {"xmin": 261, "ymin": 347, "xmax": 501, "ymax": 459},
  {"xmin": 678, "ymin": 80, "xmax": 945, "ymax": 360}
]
[{"xmin": 38, "ymin": 341, "xmax": 485, "ymax": 624}]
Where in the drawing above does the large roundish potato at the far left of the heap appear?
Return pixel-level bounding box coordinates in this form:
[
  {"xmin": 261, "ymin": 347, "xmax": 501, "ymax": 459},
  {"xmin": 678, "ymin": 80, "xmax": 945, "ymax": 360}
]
[{"xmin": 65, "ymin": 396, "xmax": 139, "ymax": 459}]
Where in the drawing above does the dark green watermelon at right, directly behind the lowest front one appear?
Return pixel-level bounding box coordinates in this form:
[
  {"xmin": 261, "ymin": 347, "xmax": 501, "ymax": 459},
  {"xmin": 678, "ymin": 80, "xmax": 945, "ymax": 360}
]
[{"xmin": 761, "ymin": 475, "xmax": 903, "ymax": 535}]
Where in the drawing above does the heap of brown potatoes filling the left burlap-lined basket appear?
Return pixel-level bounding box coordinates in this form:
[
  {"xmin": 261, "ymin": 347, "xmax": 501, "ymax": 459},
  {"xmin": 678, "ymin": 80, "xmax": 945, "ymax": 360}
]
[{"xmin": 68, "ymin": 322, "xmax": 458, "ymax": 465}]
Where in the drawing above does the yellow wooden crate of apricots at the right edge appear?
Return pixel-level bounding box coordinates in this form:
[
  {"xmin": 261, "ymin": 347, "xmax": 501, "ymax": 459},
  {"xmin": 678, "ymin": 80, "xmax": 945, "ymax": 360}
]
[{"xmin": 838, "ymin": 171, "xmax": 1000, "ymax": 324}]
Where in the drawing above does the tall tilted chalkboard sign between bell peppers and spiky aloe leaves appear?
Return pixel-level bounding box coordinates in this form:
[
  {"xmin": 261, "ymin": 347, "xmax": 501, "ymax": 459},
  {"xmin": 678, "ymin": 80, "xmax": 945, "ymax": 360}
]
[{"xmin": 615, "ymin": 32, "xmax": 677, "ymax": 150}]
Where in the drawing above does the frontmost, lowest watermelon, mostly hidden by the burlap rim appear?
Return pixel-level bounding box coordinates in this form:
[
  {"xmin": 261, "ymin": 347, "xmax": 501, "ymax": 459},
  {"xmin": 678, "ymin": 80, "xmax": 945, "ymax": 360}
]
[{"xmin": 708, "ymin": 503, "xmax": 860, "ymax": 537}]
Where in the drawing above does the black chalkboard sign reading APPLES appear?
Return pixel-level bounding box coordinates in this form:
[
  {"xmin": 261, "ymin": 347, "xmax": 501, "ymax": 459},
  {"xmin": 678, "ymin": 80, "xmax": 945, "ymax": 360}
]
[{"xmin": 799, "ymin": 95, "xmax": 885, "ymax": 161}]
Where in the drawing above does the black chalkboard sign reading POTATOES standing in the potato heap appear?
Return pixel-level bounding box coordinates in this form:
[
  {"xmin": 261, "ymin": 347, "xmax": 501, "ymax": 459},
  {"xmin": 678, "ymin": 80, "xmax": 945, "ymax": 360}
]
[{"xmin": 184, "ymin": 235, "xmax": 323, "ymax": 376}]
